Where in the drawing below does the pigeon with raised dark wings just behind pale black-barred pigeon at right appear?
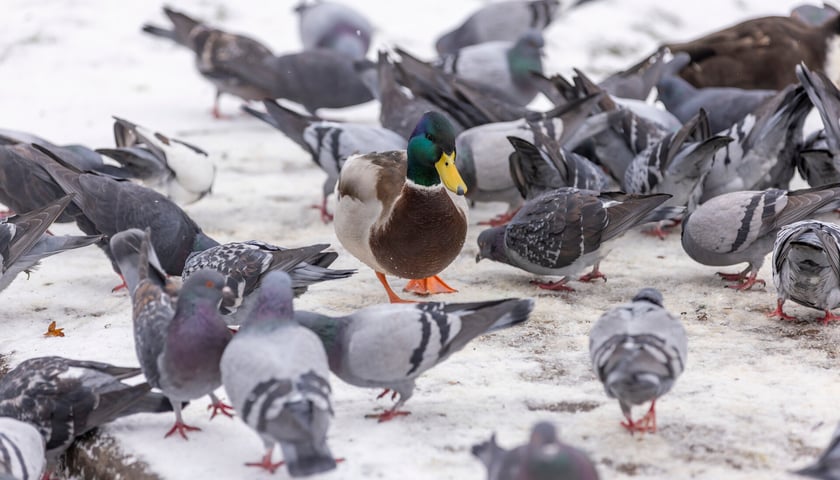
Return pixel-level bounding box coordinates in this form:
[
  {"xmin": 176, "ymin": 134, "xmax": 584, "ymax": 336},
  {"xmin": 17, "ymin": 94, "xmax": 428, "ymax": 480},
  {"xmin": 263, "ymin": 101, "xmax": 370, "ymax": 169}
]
[{"xmin": 700, "ymin": 82, "xmax": 813, "ymax": 202}]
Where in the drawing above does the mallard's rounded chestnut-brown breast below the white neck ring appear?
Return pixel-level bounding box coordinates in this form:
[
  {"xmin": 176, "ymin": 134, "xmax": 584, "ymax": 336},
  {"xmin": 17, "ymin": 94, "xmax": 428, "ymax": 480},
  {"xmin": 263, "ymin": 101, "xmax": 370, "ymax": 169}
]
[{"xmin": 370, "ymin": 186, "xmax": 467, "ymax": 279}]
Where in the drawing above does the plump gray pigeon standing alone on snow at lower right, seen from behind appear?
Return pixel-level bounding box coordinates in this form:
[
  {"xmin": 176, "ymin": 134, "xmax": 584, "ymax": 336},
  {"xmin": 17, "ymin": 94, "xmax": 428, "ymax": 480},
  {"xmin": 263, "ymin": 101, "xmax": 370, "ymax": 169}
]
[{"xmin": 589, "ymin": 288, "xmax": 688, "ymax": 433}]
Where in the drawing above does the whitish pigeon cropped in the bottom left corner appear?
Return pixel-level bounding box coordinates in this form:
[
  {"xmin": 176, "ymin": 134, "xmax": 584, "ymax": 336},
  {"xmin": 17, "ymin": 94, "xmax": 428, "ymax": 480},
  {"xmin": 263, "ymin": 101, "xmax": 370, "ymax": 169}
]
[{"xmin": 0, "ymin": 417, "xmax": 46, "ymax": 480}]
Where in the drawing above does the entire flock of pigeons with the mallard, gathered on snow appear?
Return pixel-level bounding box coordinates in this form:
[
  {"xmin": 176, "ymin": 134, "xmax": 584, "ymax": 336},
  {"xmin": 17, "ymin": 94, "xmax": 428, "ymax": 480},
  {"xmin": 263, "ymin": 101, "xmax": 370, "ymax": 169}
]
[{"xmin": 0, "ymin": 0, "xmax": 840, "ymax": 480}]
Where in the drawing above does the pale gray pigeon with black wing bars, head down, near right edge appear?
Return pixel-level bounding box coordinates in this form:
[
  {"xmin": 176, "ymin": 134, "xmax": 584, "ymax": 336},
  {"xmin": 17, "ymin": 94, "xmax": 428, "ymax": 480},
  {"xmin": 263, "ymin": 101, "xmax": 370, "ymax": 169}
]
[{"xmin": 682, "ymin": 184, "xmax": 840, "ymax": 290}]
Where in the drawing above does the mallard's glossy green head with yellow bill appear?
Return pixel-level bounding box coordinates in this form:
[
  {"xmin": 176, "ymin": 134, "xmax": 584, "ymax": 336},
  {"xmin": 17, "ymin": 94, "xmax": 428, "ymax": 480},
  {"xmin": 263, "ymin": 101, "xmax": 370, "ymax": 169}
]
[{"xmin": 406, "ymin": 112, "xmax": 467, "ymax": 195}]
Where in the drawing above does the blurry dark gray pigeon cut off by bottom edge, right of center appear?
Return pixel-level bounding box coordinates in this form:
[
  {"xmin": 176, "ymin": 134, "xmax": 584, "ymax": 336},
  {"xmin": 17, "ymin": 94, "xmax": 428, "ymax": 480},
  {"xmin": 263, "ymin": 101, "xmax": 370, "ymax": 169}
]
[{"xmin": 471, "ymin": 422, "xmax": 599, "ymax": 480}]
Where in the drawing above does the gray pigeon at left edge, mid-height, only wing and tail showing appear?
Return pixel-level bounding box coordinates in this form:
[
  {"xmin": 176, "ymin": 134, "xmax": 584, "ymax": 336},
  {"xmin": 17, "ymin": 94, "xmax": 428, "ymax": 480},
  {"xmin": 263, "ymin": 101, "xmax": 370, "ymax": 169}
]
[{"xmin": 0, "ymin": 195, "xmax": 101, "ymax": 291}]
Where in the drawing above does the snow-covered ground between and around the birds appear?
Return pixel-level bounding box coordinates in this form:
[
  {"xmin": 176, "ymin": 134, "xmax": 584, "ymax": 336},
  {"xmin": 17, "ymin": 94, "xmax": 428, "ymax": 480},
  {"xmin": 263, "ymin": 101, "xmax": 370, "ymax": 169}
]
[{"xmin": 0, "ymin": 0, "xmax": 840, "ymax": 480}]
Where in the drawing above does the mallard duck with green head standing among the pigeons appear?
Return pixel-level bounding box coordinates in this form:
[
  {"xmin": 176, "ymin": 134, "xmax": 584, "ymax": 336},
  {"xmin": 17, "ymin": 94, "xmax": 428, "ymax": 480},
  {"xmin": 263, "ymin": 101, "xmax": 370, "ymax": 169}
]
[{"xmin": 335, "ymin": 112, "xmax": 467, "ymax": 303}]
